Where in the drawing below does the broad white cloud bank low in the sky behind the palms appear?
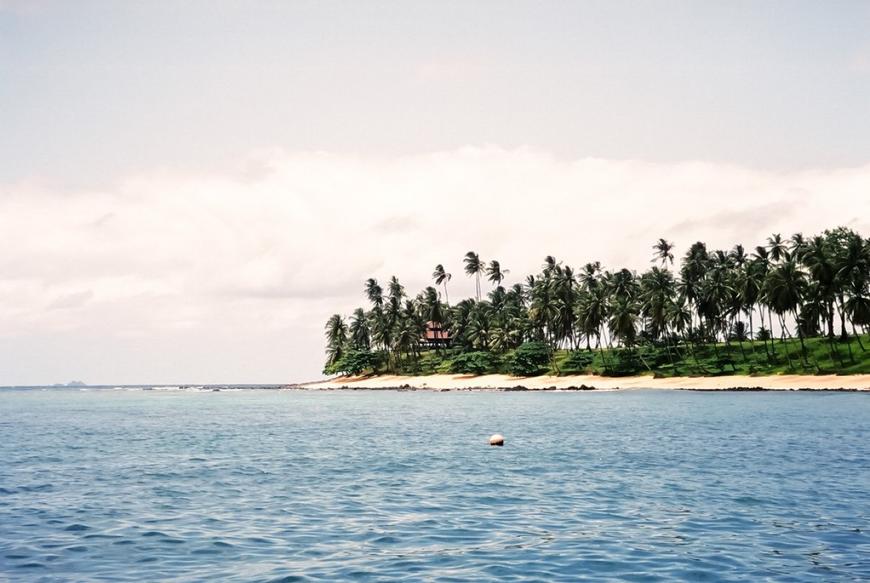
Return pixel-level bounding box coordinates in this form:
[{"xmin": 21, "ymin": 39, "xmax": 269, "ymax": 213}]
[{"xmin": 0, "ymin": 147, "xmax": 870, "ymax": 384}]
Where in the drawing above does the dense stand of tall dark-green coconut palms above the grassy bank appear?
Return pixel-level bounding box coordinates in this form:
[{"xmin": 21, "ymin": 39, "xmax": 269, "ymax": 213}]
[{"xmin": 325, "ymin": 227, "xmax": 870, "ymax": 372}]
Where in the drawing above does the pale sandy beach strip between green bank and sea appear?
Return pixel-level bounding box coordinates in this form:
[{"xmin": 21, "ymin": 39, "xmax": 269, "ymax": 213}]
[{"xmin": 304, "ymin": 374, "xmax": 870, "ymax": 392}]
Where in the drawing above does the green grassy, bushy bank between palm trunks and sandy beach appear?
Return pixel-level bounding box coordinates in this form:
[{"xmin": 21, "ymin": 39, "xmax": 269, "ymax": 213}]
[{"xmin": 351, "ymin": 335, "xmax": 870, "ymax": 377}]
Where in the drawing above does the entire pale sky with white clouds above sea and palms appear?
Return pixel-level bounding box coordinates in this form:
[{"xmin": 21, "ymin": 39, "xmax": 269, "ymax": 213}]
[{"xmin": 0, "ymin": 0, "xmax": 870, "ymax": 385}]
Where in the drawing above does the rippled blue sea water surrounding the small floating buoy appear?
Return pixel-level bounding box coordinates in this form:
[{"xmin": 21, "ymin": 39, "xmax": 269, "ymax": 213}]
[{"xmin": 0, "ymin": 389, "xmax": 870, "ymax": 581}]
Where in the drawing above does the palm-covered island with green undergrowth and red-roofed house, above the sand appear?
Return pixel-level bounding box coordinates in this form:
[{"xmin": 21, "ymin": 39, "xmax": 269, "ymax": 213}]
[{"xmin": 324, "ymin": 227, "xmax": 870, "ymax": 388}]
